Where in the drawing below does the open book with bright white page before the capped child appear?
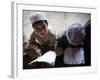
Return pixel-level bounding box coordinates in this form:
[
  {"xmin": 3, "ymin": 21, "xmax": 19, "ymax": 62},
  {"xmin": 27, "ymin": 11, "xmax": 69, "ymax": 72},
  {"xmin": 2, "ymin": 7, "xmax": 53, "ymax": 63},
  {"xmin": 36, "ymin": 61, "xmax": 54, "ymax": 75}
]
[{"xmin": 28, "ymin": 51, "xmax": 56, "ymax": 68}]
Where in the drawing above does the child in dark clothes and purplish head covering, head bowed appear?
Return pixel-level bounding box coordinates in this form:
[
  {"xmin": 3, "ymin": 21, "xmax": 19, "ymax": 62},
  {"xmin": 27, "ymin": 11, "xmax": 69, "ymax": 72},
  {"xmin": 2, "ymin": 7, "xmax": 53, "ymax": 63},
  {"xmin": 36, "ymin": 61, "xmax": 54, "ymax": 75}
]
[{"xmin": 55, "ymin": 23, "xmax": 85, "ymax": 67}]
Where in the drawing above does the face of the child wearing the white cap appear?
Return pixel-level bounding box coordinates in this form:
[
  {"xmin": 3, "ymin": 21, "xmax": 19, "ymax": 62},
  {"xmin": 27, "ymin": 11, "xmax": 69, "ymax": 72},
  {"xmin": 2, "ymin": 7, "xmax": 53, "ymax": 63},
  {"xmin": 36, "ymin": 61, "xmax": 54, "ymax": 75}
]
[{"xmin": 34, "ymin": 21, "xmax": 48, "ymax": 38}]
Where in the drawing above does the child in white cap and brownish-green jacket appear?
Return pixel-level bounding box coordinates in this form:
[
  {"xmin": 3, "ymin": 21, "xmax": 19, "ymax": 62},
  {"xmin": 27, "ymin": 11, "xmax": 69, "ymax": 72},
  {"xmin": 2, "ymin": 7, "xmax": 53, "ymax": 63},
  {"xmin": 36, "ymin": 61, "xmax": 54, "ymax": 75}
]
[{"xmin": 23, "ymin": 12, "xmax": 56, "ymax": 69}]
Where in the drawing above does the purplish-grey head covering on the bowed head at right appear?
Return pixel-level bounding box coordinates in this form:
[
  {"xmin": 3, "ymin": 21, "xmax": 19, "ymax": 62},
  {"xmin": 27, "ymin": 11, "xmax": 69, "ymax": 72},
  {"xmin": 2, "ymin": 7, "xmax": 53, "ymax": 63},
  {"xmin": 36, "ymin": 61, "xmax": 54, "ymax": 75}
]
[{"xmin": 66, "ymin": 23, "xmax": 85, "ymax": 45}]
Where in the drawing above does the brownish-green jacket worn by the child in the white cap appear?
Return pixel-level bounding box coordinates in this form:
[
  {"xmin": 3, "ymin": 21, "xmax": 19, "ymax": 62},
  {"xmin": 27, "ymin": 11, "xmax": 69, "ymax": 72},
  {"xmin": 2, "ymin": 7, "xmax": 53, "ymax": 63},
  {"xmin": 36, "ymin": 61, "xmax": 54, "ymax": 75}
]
[{"xmin": 28, "ymin": 31, "xmax": 56, "ymax": 56}]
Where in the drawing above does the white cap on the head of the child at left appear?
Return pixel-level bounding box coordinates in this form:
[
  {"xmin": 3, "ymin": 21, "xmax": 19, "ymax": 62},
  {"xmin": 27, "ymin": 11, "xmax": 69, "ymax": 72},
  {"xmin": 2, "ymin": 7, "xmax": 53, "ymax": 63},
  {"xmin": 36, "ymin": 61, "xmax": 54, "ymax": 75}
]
[{"xmin": 30, "ymin": 12, "xmax": 47, "ymax": 24}]
